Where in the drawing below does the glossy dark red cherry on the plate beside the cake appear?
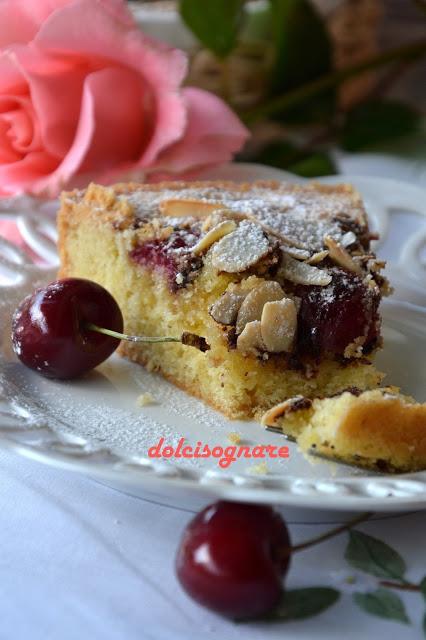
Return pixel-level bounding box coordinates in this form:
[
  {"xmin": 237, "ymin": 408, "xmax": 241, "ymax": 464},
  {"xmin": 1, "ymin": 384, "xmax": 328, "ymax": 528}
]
[{"xmin": 12, "ymin": 278, "xmax": 123, "ymax": 379}]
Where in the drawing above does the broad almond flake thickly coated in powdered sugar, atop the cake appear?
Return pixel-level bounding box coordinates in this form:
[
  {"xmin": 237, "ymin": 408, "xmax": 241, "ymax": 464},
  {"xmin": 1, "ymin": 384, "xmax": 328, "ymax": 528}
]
[{"xmin": 211, "ymin": 220, "xmax": 270, "ymax": 273}]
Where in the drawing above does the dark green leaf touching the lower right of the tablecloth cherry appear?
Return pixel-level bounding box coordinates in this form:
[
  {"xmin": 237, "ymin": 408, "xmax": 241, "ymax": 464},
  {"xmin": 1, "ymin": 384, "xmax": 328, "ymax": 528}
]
[{"xmin": 266, "ymin": 587, "xmax": 340, "ymax": 622}]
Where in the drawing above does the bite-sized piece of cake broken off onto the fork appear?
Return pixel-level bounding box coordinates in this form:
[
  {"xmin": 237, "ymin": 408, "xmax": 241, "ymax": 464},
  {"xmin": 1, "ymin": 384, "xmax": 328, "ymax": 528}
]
[{"xmin": 262, "ymin": 387, "xmax": 426, "ymax": 472}]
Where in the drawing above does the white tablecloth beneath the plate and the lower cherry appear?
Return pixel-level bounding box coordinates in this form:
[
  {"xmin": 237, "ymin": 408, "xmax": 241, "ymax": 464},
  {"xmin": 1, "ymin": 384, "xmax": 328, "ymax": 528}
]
[{"xmin": 0, "ymin": 157, "xmax": 426, "ymax": 640}]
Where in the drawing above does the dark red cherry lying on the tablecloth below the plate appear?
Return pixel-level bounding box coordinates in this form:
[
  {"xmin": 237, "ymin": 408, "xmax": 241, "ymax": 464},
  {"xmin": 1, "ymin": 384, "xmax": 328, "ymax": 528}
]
[{"xmin": 176, "ymin": 502, "xmax": 290, "ymax": 620}]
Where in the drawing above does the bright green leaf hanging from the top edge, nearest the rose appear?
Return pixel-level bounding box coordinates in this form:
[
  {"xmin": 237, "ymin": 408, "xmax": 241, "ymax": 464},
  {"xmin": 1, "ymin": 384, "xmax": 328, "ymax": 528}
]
[{"xmin": 180, "ymin": 0, "xmax": 243, "ymax": 58}]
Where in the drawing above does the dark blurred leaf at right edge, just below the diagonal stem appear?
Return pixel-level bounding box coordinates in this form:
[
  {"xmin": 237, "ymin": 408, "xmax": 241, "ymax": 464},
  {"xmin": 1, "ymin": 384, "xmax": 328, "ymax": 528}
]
[{"xmin": 341, "ymin": 100, "xmax": 421, "ymax": 151}]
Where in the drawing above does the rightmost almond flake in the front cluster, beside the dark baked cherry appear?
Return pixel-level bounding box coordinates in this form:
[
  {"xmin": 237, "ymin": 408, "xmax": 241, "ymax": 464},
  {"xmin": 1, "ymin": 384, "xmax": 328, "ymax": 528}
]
[{"xmin": 260, "ymin": 298, "xmax": 297, "ymax": 353}]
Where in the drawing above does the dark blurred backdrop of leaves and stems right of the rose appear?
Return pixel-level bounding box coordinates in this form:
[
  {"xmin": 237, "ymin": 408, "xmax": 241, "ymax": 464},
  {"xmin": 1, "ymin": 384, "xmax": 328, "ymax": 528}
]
[{"xmin": 129, "ymin": 0, "xmax": 426, "ymax": 177}]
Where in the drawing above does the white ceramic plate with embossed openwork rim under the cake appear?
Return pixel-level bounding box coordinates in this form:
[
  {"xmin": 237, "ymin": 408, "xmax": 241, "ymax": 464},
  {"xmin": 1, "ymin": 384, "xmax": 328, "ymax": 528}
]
[{"xmin": 0, "ymin": 165, "xmax": 426, "ymax": 511}]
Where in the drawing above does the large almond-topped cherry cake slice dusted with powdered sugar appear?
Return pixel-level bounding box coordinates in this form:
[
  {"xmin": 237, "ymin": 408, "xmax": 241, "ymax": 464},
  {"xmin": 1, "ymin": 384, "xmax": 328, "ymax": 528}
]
[{"xmin": 59, "ymin": 182, "xmax": 388, "ymax": 418}]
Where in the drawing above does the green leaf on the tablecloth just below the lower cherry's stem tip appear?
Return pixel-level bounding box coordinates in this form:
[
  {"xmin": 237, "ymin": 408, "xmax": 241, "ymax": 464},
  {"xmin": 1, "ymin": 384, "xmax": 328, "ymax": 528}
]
[{"xmin": 345, "ymin": 530, "xmax": 405, "ymax": 580}]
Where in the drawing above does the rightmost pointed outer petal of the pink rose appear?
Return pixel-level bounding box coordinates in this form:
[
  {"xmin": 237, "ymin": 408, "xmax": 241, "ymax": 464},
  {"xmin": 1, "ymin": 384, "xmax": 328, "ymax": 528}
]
[{"xmin": 150, "ymin": 87, "xmax": 249, "ymax": 173}]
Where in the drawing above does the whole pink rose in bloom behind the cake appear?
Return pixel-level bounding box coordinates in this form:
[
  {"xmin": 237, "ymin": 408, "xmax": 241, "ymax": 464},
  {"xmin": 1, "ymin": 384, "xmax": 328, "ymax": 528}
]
[{"xmin": 0, "ymin": 0, "xmax": 248, "ymax": 196}]
